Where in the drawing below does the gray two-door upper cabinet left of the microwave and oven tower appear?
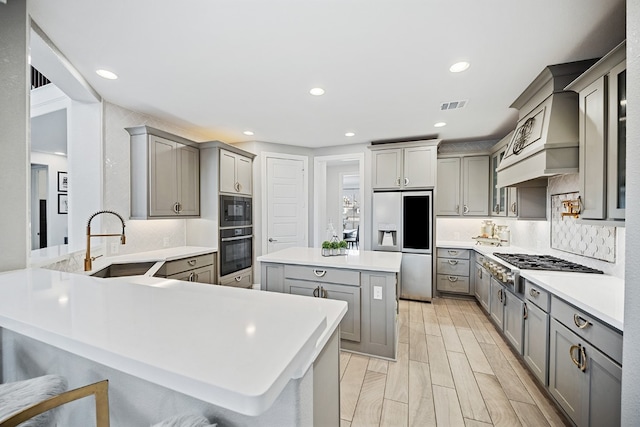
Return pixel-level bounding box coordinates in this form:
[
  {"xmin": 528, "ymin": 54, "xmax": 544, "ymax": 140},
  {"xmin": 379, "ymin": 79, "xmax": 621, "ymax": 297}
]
[{"xmin": 127, "ymin": 126, "xmax": 200, "ymax": 219}]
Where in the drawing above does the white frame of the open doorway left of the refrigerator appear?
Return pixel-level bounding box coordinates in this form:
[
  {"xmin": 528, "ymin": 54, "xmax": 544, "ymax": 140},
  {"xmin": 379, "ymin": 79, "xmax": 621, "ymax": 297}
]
[{"xmin": 313, "ymin": 153, "xmax": 367, "ymax": 249}]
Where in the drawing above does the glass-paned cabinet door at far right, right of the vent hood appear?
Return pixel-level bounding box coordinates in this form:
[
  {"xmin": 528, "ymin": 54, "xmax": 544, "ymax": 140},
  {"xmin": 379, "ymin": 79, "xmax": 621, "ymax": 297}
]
[{"xmin": 607, "ymin": 61, "xmax": 627, "ymax": 219}]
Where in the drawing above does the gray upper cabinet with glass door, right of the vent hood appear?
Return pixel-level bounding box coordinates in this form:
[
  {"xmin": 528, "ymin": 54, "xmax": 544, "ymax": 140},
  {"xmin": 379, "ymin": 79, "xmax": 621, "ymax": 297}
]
[{"xmin": 567, "ymin": 42, "xmax": 626, "ymax": 220}]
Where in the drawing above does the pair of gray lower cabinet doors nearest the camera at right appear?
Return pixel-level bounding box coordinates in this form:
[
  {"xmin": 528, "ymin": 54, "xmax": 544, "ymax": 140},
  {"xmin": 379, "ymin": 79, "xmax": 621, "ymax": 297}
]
[{"xmin": 549, "ymin": 318, "xmax": 622, "ymax": 427}]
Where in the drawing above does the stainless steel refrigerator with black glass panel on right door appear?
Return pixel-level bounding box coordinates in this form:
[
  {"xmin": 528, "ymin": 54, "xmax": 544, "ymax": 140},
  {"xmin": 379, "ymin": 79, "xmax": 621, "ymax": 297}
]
[{"xmin": 372, "ymin": 190, "xmax": 435, "ymax": 301}]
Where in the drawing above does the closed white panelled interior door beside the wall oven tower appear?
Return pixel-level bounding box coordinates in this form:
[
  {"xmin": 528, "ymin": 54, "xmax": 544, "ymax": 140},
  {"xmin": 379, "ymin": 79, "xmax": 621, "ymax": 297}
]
[{"xmin": 264, "ymin": 157, "xmax": 308, "ymax": 253}]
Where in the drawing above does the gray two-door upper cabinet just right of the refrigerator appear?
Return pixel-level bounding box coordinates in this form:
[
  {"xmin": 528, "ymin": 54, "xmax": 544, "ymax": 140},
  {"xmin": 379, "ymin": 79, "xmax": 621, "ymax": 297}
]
[{"xmin": 436, "ymin": 156, "xmax": 489, "ymax": 216}]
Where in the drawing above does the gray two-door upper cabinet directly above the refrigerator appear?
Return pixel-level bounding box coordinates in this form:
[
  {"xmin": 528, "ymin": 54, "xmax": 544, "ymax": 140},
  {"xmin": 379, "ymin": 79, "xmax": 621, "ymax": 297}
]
[{"xmin": 369, "ymin": 140, "xmax": 440, "ymax": 190}]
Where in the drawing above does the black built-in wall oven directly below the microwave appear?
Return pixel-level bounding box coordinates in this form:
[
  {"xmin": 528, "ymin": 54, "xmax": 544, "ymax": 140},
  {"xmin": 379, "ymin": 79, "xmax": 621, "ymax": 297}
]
[{"xmin": 220, "ymin": 227, "xmax": 253, "ymax": 276}]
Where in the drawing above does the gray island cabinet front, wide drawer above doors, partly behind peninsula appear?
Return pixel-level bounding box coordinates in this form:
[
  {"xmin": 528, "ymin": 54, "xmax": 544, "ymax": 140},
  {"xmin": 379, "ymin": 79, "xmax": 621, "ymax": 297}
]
[{"xmin": 284, "ymin": 279, "xmax": 360, "ymax": 342}]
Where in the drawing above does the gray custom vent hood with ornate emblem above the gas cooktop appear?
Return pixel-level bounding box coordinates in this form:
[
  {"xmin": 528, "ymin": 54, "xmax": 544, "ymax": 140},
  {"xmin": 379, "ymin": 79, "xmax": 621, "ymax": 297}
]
[{"xmin": 497, "ymin": 59, "xmax": 596, "ymax": 187}]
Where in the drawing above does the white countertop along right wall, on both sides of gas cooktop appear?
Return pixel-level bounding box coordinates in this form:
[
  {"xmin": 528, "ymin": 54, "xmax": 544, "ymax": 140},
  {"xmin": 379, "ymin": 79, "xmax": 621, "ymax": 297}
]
[{"xmin": 436, "ymin": 241, "xmax": 625, "ymax": 331}]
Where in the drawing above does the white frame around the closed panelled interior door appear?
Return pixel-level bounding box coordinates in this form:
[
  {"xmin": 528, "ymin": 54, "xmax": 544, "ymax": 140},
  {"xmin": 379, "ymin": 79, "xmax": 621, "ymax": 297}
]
[{"xmin": 262, "ymin": 151, "xmax": 309, "ymax": 254}]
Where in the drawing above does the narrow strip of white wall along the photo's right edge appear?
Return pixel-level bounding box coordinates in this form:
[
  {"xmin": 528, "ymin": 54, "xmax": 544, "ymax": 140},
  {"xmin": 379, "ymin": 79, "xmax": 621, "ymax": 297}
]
[{"xmin": 622, "ymin": 0, "xmax": 640, "ymax": 426}]
